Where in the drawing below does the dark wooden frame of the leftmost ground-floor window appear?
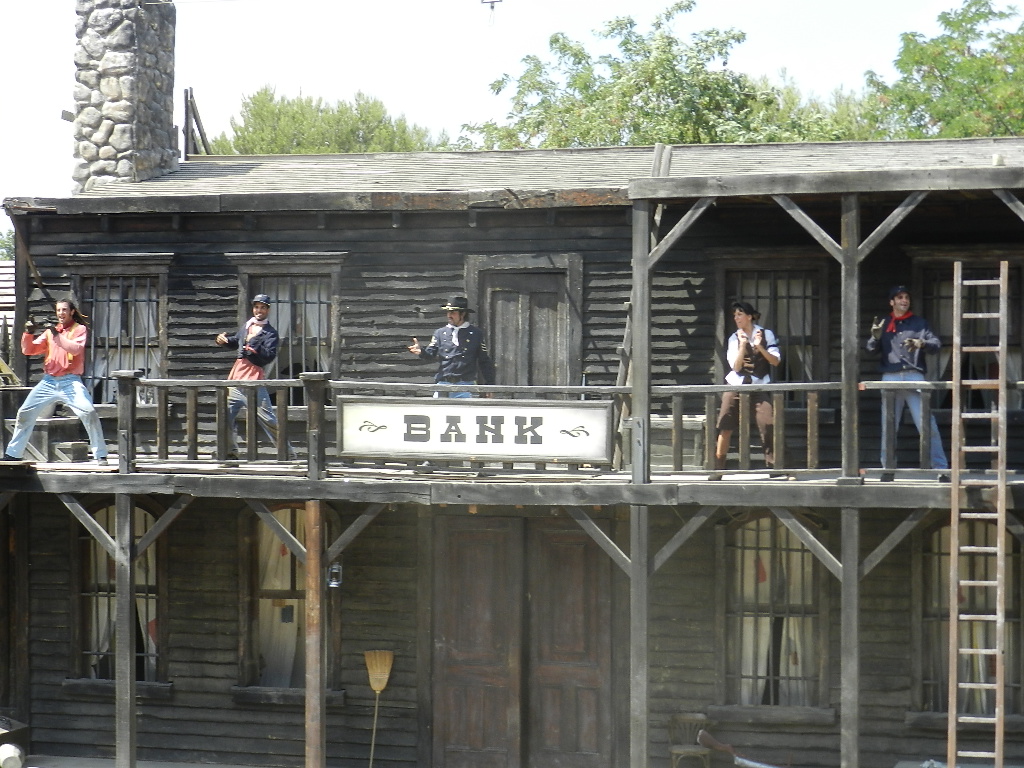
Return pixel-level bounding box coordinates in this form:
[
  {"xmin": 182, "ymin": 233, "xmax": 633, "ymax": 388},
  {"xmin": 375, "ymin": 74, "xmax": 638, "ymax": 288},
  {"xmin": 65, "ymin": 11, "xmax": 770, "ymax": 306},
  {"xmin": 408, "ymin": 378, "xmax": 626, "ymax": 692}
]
[{"xmin": 65, "ymin": 497, "xmax": 170, "ymax": 696}]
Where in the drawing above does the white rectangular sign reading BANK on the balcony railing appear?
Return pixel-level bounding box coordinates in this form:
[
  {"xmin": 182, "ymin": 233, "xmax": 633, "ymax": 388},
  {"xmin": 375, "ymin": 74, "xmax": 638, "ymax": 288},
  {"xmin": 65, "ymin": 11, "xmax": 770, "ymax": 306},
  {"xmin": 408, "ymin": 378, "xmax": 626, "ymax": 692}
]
[{"xmin": 338, "ymin": 395, "xmax": 612, "ymax": 464}]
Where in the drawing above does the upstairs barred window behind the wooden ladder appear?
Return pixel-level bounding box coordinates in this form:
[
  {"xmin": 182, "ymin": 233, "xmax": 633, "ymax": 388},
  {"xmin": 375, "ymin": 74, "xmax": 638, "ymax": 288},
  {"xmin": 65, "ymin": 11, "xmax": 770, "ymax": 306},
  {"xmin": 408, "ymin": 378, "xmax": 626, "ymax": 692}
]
[{"xmin": 910, "ymin": 260, "xmax": 1022, "ymax": 409}]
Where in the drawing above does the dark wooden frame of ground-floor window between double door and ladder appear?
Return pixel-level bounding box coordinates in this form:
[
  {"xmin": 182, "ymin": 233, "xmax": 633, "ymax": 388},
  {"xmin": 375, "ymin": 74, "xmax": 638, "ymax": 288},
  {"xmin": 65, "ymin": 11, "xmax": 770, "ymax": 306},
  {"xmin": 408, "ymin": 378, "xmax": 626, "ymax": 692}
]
[{"xmin": 713, "ymin": 509, "xmax": 836, "ymax": 724}]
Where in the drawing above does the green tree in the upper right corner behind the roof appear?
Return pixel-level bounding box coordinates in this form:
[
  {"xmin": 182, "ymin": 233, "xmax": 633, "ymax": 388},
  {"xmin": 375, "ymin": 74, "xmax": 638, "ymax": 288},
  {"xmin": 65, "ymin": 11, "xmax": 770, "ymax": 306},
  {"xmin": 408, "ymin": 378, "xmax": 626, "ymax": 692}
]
[{"xmin": 867, "ymin": 0, "xmax": 1024, "ymax": 138}]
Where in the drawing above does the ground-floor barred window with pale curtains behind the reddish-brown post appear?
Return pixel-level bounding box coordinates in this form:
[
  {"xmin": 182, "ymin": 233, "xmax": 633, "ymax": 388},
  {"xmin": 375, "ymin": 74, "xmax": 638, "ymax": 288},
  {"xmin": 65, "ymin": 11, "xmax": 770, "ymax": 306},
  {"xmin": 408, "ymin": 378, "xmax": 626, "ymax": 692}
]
[{"xmin": 242, "ymin": 505, "xmax": 340, "ymax": 689}]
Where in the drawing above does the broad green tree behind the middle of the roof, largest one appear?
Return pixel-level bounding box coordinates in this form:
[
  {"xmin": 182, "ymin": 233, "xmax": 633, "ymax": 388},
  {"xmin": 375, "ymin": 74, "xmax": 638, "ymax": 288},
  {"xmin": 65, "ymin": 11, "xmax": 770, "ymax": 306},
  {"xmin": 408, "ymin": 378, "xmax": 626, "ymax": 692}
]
[{"xmin": 462, "ymin": 0, "xmax": 867, "ymax": 148}]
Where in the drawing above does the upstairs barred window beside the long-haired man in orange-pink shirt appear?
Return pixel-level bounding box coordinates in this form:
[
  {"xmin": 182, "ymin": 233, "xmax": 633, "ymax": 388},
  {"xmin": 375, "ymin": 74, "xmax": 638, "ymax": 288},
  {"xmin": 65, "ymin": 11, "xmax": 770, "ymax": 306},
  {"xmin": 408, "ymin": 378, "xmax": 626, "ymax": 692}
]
[{"xmin": 78, "ymin": 269, "xmax": 166, "ymax": 403}]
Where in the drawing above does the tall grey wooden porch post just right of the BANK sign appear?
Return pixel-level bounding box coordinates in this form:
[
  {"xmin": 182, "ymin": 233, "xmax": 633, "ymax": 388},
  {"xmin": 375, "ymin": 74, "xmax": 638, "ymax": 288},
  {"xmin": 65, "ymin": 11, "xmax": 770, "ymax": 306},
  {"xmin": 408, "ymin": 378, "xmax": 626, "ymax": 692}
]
[{"xmin": 630, "ymin": 200, "xmax": 651, "ymax": 768}]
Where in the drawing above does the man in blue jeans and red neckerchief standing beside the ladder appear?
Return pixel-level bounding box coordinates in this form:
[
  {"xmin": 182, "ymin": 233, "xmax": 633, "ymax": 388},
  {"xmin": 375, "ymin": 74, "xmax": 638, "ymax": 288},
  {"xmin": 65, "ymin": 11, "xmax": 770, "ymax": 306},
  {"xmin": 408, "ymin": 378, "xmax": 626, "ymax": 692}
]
[{"xmin": 867, "ymin": 286, "xmax": 949, "ymax": 481}]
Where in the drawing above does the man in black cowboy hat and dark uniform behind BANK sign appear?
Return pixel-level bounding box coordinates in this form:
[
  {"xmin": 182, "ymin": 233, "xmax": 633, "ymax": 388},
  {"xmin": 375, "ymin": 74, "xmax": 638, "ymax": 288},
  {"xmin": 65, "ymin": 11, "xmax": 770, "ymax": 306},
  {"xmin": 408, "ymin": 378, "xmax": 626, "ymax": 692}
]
[{"xmin": 408, "ymin": 296, "xmax": 495, "ymax": 397}]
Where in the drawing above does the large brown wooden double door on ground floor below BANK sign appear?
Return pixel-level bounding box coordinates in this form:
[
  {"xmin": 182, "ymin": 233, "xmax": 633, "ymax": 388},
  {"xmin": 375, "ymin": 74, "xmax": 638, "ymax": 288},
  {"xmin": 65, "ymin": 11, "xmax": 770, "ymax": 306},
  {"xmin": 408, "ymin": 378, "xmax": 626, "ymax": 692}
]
[{"xmin": 433, "ymin": 517, "xmax": 612, "ymax": 768}]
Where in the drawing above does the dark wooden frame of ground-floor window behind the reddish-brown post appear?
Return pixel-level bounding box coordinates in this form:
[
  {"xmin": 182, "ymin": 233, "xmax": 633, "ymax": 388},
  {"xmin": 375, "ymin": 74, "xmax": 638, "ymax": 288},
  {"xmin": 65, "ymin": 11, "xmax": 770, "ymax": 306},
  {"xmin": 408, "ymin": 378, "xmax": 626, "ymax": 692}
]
[{"xmin": 232, "ymin": 502, "xmax": 344, "ymax": 703}]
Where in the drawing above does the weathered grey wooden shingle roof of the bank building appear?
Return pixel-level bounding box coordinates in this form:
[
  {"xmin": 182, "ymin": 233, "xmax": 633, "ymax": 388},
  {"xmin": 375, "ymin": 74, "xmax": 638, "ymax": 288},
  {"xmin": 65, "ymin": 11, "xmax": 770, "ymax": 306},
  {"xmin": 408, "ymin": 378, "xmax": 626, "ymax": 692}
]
[{"xmin": 7, "ymin": 138, "xmax": 1024, "ymax": 213}]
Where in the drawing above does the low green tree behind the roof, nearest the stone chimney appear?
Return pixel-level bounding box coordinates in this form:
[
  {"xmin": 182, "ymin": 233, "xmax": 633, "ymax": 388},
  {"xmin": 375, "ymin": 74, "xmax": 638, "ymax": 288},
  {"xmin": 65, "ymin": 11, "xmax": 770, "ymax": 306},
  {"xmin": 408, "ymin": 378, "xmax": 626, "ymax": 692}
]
[{"xmin": 211, "ymin": 86, "xmax": 447, "ymax": 155}]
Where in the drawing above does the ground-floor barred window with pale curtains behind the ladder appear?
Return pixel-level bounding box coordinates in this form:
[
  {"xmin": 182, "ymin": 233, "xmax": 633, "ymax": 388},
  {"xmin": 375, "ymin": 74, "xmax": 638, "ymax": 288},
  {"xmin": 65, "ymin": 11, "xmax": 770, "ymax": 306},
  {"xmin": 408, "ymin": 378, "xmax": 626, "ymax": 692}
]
[{"xmin": 914, "ymin": 520, "xmax": 1024, "ymax": 715}]
